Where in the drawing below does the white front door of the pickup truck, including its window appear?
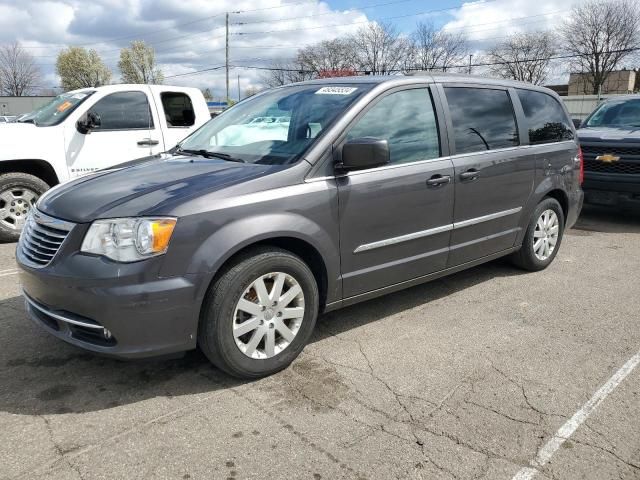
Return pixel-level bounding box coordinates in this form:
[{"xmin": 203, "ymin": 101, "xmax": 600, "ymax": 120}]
[{"xmin": 65, "ymin": 86, "xmax": 164, "ymax": 177}]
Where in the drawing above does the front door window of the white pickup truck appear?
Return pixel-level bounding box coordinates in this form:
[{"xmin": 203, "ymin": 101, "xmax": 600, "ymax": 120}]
[{"xmin": 90, "ymin": 92, "xmax": 153, "ymax": 131}]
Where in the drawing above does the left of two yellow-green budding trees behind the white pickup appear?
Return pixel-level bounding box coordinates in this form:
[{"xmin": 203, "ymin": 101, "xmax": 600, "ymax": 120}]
[{"xmin": 56, "ymin": 47, "xmax": 111, "ymax": 90}]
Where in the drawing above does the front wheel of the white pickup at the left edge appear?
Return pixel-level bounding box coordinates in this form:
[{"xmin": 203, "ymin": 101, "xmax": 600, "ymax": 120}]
[{"xmin": 0, "ymin": 172, "xmax": 49, "ymax": 242}]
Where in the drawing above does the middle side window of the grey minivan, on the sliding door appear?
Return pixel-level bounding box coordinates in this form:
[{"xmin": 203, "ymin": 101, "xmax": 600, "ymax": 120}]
[{"xmin": 444, "ymin": 87, "xmax": 519, "ymax": 153}]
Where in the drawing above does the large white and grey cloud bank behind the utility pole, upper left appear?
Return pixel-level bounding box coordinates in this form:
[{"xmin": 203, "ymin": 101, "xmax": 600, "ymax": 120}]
[{"xmin": 0, "ymin": 0, "xmax": 368, "ymax": 96}]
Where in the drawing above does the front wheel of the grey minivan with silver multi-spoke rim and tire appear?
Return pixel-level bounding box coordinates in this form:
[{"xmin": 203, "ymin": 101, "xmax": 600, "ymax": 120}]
[{"xmin": 198, "ymin": 248, "xmax": 319, "ymax": 379}]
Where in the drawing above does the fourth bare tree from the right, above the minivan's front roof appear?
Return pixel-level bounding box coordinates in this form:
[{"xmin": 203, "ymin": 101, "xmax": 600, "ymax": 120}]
[{"xmin": 348, "ymin": 23, "xmax": 410, "ymax": 75}]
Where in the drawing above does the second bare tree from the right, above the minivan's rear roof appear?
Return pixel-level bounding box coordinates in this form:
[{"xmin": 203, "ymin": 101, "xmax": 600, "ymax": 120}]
[{"xmin": 485, "ymin": 32, "xmax": 556, "ymax": 85}]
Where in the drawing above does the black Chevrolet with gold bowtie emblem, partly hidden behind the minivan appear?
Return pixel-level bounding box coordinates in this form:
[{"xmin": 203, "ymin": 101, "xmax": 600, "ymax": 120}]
[{"xmin": 578, "ymin": 95, "xmax": 640, "ymax": 207}]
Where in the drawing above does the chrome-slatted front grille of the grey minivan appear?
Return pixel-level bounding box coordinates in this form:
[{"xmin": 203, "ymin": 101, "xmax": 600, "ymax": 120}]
[{"xmin": 19, "ymin": 210, "xmax": 73, "ymax": 268}]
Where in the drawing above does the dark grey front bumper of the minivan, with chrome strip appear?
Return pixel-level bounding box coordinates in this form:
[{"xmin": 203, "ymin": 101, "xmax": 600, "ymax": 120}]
[{"xmin": 18, "ymin": 254, "xmax": 208, "ymax": 358}]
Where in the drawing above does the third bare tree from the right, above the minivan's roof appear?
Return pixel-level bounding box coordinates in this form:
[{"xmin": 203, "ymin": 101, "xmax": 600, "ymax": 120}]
[{"xmin": 409, "ymin": 22, "xmax": 469, "ymax": 70}]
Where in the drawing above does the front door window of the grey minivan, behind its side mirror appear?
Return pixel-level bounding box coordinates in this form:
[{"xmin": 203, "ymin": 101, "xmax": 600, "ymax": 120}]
[{"xmin": 347, "ymin": 88, "xmax": 440, "ymax": 163}]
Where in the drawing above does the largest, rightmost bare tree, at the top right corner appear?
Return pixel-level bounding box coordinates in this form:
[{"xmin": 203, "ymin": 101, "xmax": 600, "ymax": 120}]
[{"xmin": 561, "ymin": 0, "xmax": 640, "ymax": 94}]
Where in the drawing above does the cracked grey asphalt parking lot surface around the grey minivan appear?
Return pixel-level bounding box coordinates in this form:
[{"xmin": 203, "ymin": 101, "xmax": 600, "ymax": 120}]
[{"xmin": 0, "ymin": 204, "xmax": 640, "ymax": 480}]
